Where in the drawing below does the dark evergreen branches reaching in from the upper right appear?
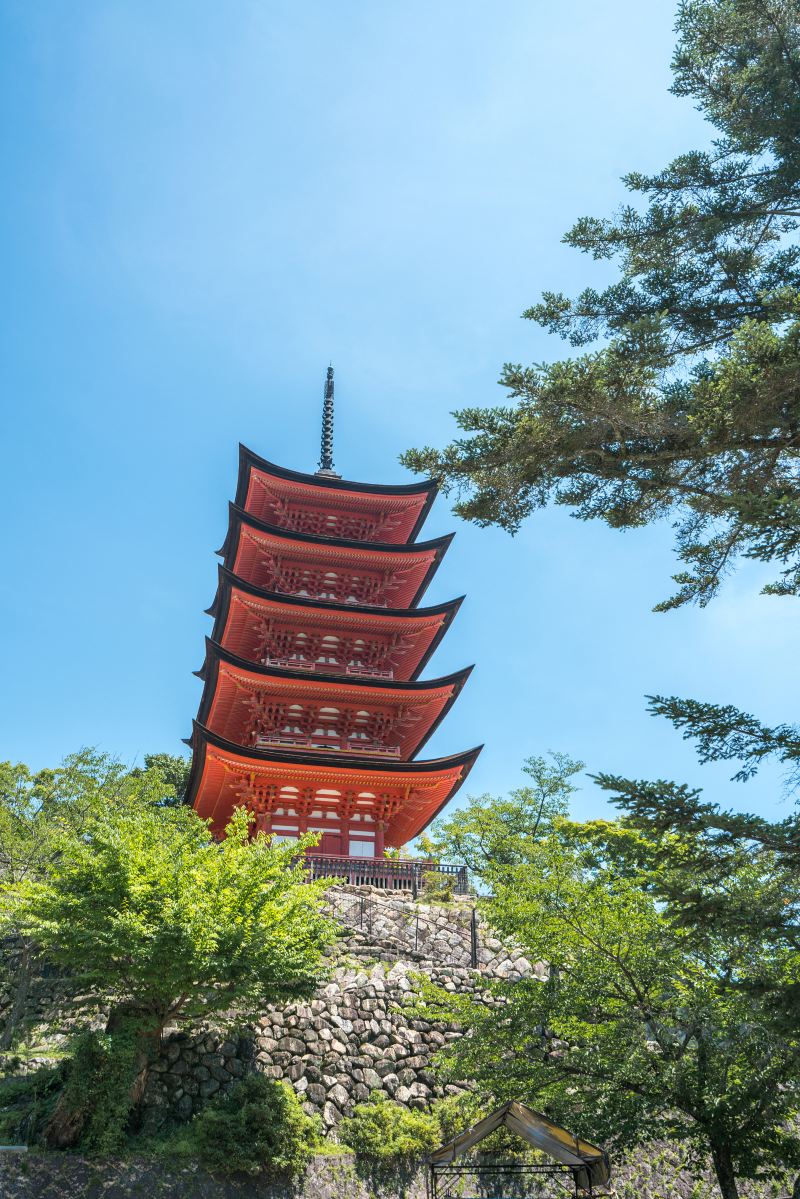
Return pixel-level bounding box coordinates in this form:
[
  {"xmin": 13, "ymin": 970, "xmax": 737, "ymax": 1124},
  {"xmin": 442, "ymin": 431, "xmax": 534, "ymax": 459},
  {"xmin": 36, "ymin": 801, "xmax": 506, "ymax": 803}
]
[{"xmin": 403, "ymin": 0, "xmax": 800, "ymax": 609}]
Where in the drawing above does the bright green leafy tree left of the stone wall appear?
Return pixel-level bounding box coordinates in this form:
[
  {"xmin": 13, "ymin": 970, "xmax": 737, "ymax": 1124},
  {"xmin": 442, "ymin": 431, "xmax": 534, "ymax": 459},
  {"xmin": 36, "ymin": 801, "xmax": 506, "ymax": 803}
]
[{"xmin": 0, "ymin": 771, "xmax": 335, "ymax": 1147}]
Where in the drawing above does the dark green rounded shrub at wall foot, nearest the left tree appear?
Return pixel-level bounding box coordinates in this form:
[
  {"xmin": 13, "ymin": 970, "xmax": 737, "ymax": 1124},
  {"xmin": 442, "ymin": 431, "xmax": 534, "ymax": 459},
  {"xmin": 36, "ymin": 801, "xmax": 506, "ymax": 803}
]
[{"xmin": 190, "ymin": 1074, "xmax": 320, "ymax": 1177}]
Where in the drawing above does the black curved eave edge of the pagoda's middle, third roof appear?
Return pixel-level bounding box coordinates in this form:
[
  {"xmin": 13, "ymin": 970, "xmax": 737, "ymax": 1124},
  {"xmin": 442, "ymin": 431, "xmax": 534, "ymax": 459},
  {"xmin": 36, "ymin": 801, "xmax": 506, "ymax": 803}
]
[{"xmin": 205, "ymin": 562, "xmax": 465, "ymax": 681}]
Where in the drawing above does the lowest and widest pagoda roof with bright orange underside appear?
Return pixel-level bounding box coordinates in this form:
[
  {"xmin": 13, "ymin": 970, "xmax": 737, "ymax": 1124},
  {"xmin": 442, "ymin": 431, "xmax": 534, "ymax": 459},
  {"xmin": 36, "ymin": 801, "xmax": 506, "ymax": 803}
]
[{"xmin": 185, "ymin": 721, "xmax": 483, "ymax": 845}]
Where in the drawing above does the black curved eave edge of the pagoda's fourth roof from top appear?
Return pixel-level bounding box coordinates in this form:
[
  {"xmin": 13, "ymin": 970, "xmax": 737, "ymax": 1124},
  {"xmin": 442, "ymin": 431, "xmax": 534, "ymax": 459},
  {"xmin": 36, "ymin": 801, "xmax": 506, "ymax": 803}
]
[{"xmin": 194, "ymin": 637, "xmax": 474, "ymax": 761}]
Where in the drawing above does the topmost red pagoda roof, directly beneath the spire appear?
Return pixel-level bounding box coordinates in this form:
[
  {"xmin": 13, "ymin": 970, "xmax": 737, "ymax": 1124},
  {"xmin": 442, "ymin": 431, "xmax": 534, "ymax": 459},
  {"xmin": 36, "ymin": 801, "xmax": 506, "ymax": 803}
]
[{"xmin": 235, "ymin": 445, "xmax": 439, "ymax": 542}]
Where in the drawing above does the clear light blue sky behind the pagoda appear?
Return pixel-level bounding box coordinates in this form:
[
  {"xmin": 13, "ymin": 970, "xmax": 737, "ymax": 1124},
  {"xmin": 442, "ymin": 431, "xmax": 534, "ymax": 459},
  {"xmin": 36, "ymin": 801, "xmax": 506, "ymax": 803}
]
[{"xmin": 0, "ymin": 0, "xmax": 800, "ymax": 814}]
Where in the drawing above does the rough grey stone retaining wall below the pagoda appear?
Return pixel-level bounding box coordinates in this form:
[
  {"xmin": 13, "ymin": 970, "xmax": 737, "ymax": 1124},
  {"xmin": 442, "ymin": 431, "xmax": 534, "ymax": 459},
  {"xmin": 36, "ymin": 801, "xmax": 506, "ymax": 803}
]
[{"xmin": 0, "ymin": 886, "xmax": 543, "ymax": 1131}]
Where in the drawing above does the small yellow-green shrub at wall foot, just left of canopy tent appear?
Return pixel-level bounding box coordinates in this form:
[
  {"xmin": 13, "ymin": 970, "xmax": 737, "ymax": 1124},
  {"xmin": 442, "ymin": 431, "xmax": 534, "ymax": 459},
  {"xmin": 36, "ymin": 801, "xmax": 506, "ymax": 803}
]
[{"xmin": 339, "ymin": 1092, "xmax": 439, "ymax": 1165}]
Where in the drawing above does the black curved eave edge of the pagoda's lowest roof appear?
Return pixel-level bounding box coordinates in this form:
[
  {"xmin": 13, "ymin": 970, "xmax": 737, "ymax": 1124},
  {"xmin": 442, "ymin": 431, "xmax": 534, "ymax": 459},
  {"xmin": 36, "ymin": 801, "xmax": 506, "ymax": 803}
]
[{"xmin": 186, "ymin": 721, "xmax": 483, "ymax": 815}]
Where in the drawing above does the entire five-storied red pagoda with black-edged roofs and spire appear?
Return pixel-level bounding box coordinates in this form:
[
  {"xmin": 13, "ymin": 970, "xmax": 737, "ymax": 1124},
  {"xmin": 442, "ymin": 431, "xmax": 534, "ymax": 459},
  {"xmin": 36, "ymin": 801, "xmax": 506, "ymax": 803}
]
[{"xmin": 187, "ymin": 367, "xmax": 480, "ymax": 885}]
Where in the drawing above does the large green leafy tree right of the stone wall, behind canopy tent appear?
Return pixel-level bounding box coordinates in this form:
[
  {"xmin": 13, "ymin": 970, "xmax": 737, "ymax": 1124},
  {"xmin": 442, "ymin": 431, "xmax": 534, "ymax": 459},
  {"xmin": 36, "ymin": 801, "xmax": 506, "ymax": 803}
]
[{"xmin": 426, "ymin": 781, "xmax": 800, "ymax": 1199}]
